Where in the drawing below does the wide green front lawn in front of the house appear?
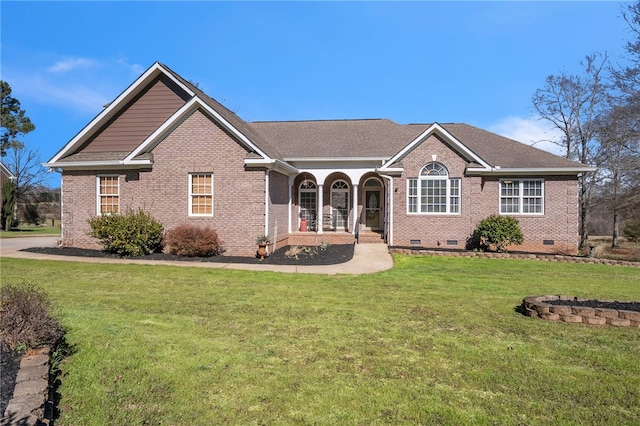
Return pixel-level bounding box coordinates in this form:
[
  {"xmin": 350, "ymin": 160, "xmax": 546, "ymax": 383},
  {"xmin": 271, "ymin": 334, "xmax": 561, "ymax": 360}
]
[{"xmin": 1, "ymin": 256, "xmax": 640, "ymax": 425}]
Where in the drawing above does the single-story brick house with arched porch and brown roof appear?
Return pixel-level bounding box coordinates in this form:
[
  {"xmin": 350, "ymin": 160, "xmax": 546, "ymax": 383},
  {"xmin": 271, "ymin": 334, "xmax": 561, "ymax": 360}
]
[{"xmin": 44, "ymin": 63, "xmax": 593, "ymax": 256}]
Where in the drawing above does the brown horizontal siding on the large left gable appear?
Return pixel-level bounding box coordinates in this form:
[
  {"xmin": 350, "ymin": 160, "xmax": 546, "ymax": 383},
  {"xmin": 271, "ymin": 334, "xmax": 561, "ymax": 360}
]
[{"xmin": 79, "ymin": 75, "xmax": 188, "ymax": 153}]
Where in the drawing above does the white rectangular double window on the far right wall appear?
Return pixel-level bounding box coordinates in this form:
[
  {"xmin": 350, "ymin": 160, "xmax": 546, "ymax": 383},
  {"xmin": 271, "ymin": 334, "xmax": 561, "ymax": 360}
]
[{"xmin": 500, "ymin": 179, "xmax": 544, "ymax": 214}]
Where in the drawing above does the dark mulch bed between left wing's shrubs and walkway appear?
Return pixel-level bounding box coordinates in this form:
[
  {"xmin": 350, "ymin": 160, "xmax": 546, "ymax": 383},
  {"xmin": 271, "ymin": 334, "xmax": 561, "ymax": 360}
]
[{"xmin": 24, "ymin": 244, "xmax": 354, "ymax": 265}]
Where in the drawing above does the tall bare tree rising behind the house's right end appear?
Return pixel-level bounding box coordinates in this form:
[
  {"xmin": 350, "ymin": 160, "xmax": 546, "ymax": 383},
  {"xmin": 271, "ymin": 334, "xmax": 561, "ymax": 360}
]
[{"xmin": 532, "ymin": 53, "xmax": 608, "ymax": 247}]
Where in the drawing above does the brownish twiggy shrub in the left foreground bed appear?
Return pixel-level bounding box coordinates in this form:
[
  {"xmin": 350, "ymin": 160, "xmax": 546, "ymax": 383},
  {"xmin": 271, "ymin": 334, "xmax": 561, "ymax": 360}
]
[{"xmin": 0, "ymin": 282, "xmax": 63, "ymax": 350}]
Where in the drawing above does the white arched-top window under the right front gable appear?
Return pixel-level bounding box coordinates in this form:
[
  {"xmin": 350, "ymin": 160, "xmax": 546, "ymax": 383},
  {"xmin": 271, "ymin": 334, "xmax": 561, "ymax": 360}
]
[{"xmin": 407, "ymin": 162, "xmax": 460, "ymax": 214}]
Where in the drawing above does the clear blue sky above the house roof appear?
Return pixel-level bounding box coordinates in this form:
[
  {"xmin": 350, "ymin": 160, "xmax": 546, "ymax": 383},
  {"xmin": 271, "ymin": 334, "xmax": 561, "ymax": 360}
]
[{"xmin": 0, "ymin": 0, "xmax": 632, "ymax": 186}]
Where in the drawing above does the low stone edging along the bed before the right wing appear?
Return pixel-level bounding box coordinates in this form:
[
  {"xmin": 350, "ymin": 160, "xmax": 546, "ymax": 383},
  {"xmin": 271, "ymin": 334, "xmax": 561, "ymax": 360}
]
[{"xmin": 389, "ymin": 247, "xmax": 640, "ymax": 268}]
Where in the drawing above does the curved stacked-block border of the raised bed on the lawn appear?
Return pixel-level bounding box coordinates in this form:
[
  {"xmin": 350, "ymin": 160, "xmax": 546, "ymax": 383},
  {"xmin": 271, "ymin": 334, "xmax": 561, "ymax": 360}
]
[{"xmin": 522, "ymin": 296, "xmax": 640, "ymax": 328}]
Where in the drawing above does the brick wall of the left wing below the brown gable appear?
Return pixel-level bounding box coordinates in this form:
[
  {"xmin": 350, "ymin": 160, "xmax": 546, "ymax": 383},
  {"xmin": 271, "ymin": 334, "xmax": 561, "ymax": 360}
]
[{"xmin": 62, "ymin": 111, "xmax": 268, "ymax": 255}]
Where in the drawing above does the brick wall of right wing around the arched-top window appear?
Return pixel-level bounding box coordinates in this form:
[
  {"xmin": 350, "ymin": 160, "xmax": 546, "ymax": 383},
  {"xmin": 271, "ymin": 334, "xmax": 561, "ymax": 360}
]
[{"xmin": 392, "ymin": 136, "xmax": 578, "ymax": 254}]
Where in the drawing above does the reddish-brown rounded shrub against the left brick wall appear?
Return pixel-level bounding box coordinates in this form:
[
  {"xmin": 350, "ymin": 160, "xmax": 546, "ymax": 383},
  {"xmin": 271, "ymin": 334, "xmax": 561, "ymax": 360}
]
[{"xmin": 164, "ymin": 225, "xmax": 224, "ymax": 257}]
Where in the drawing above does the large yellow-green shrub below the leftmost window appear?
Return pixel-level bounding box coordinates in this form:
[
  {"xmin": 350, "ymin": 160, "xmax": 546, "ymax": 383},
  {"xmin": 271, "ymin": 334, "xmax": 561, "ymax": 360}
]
[{"xmin": 89, "ymin": 209, "xmax": 164, "ymax": 256}]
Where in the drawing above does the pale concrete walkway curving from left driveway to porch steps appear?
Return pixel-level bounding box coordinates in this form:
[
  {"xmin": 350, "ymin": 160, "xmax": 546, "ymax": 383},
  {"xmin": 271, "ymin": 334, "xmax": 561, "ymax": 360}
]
[{"xmin": 0, "ymin": 237, "xmax": 393, "ymax": 275}]
